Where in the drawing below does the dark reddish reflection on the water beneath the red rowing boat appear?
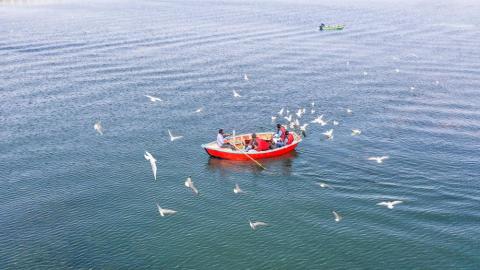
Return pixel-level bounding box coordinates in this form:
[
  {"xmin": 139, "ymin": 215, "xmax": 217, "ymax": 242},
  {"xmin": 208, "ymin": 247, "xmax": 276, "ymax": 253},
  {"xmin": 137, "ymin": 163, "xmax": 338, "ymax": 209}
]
[{"xmin": 207, "ymin": 151, "xmax": 298, "ymax": 176}]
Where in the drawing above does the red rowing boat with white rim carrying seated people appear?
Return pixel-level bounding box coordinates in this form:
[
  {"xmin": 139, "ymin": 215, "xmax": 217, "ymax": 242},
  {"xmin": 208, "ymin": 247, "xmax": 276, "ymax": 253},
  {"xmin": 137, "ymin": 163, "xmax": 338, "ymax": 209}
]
[{"xmin": 202, "ymin": 131, "xmax": 302, "ymax": 160}]
